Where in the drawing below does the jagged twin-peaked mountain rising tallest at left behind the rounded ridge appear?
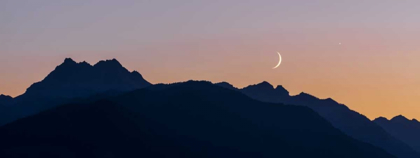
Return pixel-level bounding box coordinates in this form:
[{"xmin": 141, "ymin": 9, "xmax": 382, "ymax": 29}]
[{"xmin": 0, "ymin": 58, "xmax": 151, "ymax": 125}]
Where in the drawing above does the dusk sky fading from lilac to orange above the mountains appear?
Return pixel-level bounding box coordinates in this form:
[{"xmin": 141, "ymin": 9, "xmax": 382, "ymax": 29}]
[{"xmin": 0, "ymin": 0, "xmax": 420, "ymax": 119}]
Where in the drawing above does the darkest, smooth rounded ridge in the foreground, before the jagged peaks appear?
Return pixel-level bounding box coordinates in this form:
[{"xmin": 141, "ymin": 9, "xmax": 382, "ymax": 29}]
[{"xmin": 0, "ymin": 81, "xmax": 394, "ymax": 158}]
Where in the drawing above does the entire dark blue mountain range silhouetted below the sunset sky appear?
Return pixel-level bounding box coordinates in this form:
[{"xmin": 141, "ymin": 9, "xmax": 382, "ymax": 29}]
[{"xmin": 0, "ymin": 58, "xmax": 420, "ymax": 158}]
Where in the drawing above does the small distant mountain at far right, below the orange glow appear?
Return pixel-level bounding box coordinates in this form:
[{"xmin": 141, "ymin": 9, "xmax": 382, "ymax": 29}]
[{"xmin": 374, "ymin": 115, "xmax": 420, "ymax": 152}]
